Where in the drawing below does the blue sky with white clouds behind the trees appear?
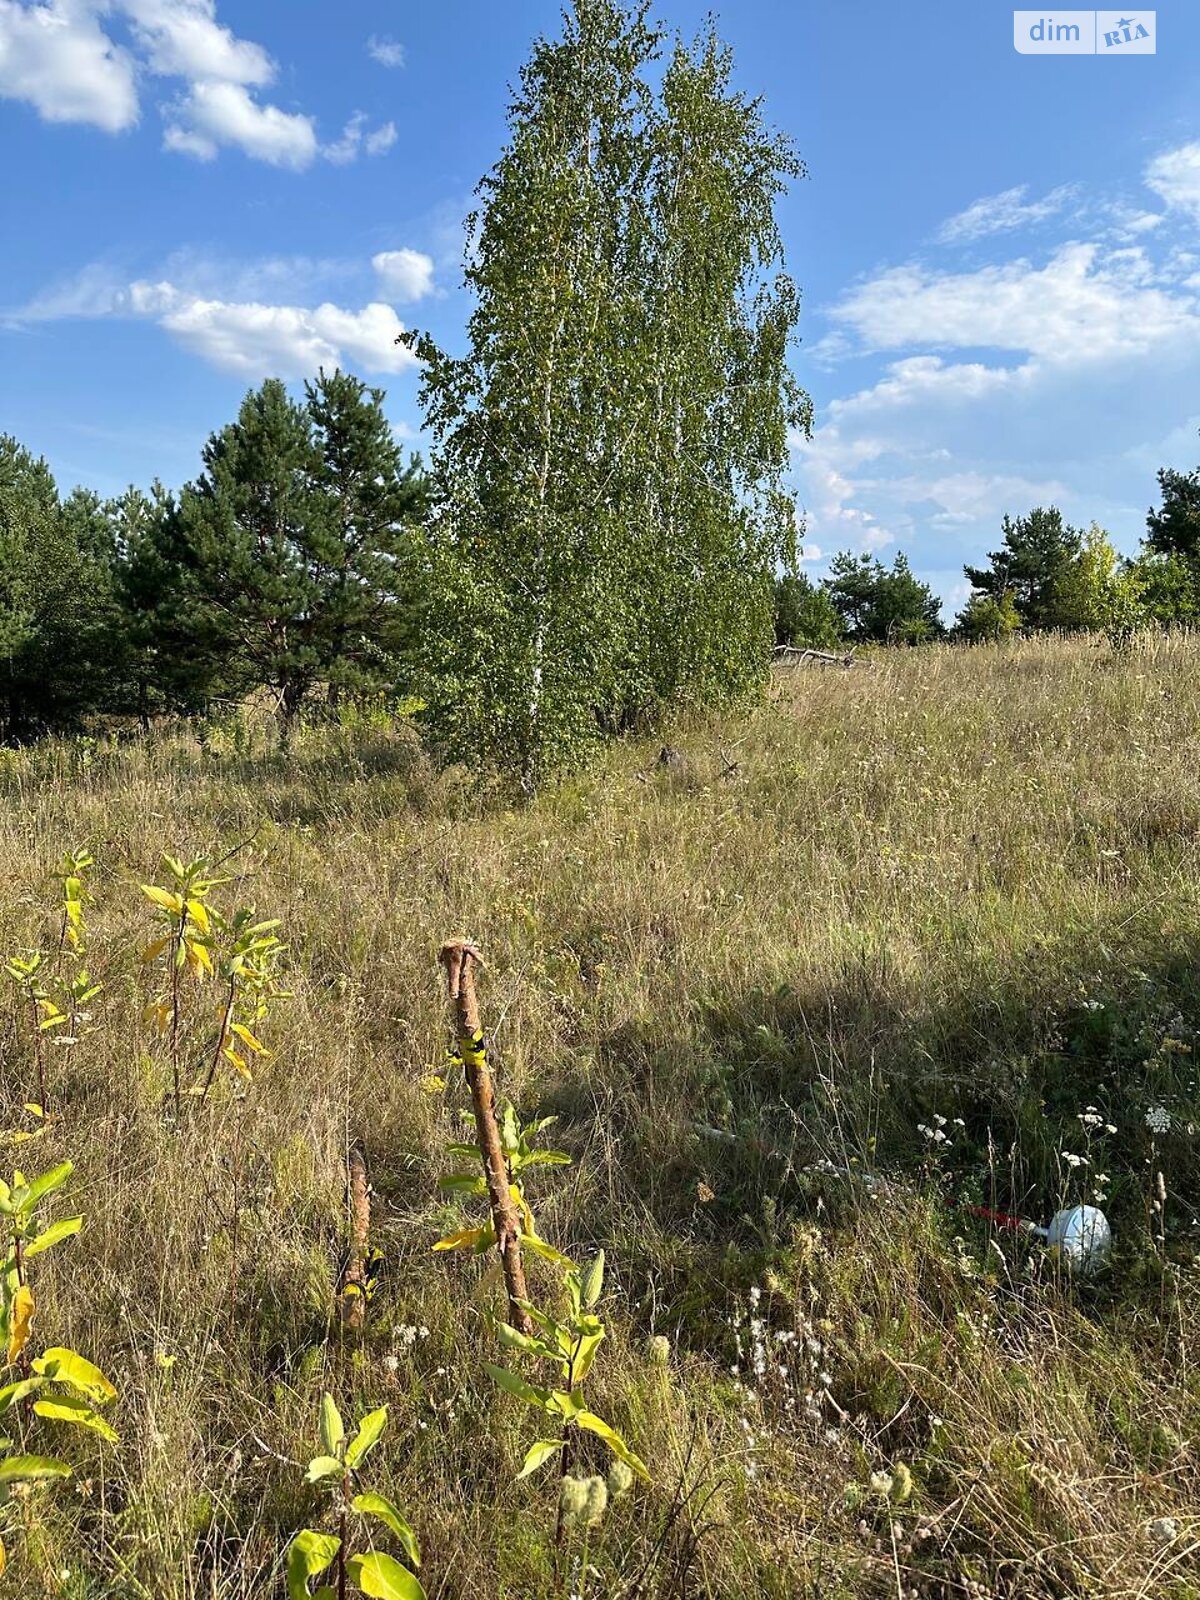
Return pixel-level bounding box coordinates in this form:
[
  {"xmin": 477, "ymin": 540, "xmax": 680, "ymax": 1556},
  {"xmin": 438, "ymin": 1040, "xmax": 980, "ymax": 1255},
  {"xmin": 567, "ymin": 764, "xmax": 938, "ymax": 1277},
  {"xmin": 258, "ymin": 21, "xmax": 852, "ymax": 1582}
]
[{"xmin": 0, "ymin": 0, "xmax": 1200, "ymax": 606}]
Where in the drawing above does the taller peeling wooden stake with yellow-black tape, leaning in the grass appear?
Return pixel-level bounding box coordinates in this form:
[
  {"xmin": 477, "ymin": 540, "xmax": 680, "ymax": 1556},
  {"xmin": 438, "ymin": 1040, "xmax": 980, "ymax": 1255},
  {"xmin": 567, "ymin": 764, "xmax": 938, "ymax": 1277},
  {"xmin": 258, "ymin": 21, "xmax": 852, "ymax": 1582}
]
[{"xmin": 438, "ymin": 939, "xmax": 534, "ymax": 1334}]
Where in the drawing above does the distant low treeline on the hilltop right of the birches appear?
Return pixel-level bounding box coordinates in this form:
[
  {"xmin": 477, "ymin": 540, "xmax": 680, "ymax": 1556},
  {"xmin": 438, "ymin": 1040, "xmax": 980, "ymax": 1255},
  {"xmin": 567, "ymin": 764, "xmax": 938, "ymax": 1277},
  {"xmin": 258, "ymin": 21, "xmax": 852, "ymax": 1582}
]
[{"xmin": 774, "ymin": 438, "xmax": 1200, "ymax": 650}]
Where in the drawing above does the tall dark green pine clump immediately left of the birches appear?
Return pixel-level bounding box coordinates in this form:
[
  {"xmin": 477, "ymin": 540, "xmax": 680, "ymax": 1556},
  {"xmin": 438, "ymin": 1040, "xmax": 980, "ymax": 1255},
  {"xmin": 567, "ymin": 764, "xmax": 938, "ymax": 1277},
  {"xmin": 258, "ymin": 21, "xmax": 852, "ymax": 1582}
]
[{"xmin": 125, "ymin": 373, "xmax": 426, "ymax": 738}]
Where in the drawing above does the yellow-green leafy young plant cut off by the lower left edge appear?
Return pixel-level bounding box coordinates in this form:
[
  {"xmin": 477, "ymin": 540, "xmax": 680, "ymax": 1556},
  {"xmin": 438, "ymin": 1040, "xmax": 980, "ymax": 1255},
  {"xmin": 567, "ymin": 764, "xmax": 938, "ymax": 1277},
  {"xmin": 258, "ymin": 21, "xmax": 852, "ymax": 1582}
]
[{"xmin": 0, "ymin": 1162, "xmax": 117, "ymax": 1571}]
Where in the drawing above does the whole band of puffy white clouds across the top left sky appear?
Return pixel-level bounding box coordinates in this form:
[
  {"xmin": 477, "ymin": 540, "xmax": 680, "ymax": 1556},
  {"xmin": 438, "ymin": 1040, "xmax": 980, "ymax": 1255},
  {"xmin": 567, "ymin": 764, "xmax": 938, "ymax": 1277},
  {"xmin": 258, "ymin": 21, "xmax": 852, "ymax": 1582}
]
[{"xmin": 0, "ymin": 0, "xmax": 385, "ymax": 170}]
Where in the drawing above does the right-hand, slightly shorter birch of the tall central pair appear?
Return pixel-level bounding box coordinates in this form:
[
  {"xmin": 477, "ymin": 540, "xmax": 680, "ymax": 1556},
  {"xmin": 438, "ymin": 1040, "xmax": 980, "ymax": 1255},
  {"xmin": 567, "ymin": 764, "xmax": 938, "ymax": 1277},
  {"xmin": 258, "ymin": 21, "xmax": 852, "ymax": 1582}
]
[{"xmin": 637, "ymin": 30, "xmax": 811, "ymax": 704}]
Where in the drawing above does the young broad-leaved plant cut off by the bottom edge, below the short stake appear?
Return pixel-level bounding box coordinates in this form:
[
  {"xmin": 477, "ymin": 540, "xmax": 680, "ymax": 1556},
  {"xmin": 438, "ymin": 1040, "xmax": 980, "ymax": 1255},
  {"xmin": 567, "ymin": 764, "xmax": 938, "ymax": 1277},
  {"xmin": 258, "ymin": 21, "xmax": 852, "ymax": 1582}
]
[{"xmin": 288, "ymin": 1395, "xmax": 426, "ymax": 1600}]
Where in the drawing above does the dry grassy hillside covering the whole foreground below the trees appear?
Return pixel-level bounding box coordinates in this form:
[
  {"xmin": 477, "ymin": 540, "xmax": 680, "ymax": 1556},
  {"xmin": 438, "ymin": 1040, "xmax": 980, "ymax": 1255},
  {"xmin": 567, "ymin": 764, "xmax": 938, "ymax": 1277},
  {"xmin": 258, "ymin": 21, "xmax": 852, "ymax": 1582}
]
[{"xmin": 0, "ymin": 640, "xmax": 1200, "ymax": 1600}]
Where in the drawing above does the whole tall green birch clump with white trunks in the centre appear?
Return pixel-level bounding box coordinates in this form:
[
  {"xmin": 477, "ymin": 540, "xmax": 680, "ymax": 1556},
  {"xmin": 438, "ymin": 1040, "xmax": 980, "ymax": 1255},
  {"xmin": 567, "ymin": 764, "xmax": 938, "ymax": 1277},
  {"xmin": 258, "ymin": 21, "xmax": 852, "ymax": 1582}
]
[{"xmin": 405, "ymin": 0, "xmax": 808, "ymax": 790}]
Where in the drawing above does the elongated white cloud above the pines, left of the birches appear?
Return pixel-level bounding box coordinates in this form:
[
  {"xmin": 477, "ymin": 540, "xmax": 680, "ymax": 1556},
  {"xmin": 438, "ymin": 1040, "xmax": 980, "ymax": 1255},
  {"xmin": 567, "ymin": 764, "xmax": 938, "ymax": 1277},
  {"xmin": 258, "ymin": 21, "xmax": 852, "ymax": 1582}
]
[{"xmin": 128, "ymin": 282, "xmax": 416, "ymax": 378}]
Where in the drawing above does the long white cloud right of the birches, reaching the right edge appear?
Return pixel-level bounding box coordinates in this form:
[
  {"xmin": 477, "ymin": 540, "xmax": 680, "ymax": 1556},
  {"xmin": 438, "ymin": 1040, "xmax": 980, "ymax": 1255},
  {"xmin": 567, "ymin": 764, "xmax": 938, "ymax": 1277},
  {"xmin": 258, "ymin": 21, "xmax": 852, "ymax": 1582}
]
[{"xmin": 832, "ymin": 243, "xmax": 1200, "ymax": 363}]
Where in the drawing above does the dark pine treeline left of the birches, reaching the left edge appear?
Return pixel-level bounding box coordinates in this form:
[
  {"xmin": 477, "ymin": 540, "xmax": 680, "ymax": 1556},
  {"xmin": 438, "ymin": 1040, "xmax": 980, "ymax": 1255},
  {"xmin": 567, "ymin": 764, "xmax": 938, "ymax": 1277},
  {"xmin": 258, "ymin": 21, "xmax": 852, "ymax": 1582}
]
[{"xmin": 0, "ymin": 373, "xmax": 429, "ymax": 744}]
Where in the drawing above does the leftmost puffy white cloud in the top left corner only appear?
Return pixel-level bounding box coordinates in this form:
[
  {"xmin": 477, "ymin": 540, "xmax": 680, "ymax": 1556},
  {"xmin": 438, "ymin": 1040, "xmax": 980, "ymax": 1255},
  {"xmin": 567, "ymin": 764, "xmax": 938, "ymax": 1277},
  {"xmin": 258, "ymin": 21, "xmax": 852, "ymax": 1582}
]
[{"xmin": 0, "ymin": 0, "xmax": 138, "ymax": 131}]
